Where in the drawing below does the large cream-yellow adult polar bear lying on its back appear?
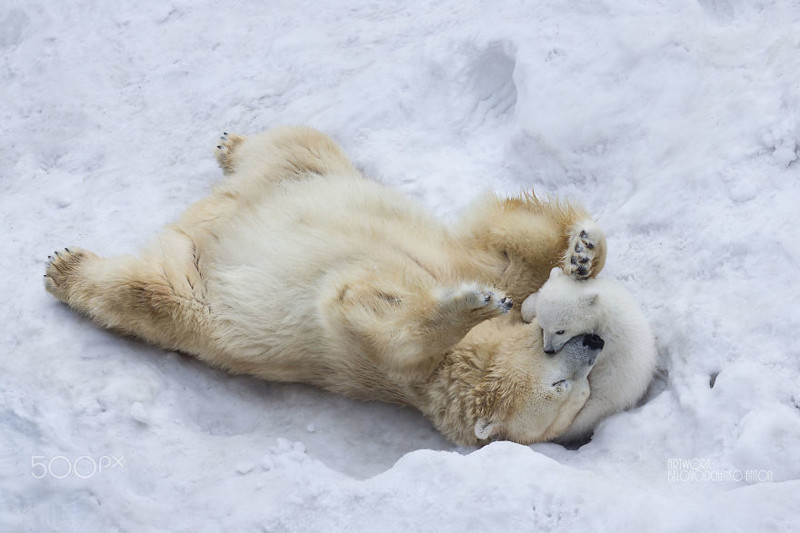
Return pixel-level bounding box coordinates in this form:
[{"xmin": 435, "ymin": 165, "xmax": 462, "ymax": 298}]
[{"xmin": 45, "ymin": 127, "xmax": 605, "ymax": 444}]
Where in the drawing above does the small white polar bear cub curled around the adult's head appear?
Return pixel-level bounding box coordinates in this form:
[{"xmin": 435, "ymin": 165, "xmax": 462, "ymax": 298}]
[{"xmin": 522, "ymin": 268, "xmax": 656, "ymax": 442}]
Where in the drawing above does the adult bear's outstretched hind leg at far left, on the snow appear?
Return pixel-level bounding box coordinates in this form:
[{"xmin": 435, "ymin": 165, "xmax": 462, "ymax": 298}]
[{"xmin": 45, "ymin": 238, "xmax": 208, "ymax": 353}]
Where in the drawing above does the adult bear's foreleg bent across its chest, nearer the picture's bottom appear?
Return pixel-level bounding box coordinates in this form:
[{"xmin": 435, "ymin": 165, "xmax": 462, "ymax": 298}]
[{"xmin": 336, "ymin": 283, "xmax": 513, "ymax": 381}]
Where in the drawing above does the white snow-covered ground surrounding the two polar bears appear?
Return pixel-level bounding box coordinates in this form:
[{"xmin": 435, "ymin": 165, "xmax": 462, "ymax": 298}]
[{"xmin": 0, "ymin": 0, "xmax": 800, "ymax": 532}]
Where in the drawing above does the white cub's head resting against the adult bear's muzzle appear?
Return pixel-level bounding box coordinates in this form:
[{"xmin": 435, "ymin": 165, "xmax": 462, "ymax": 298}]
[{"xmin": 523, "ymin": 268, "xmax": 598, "ymax": 354}]
